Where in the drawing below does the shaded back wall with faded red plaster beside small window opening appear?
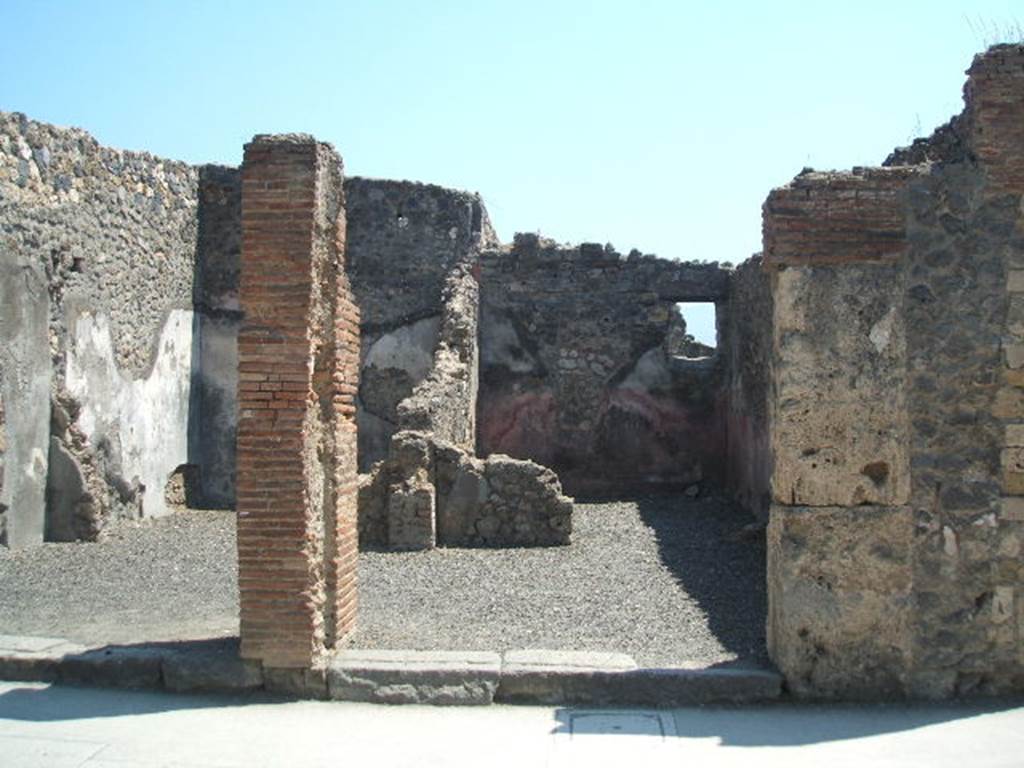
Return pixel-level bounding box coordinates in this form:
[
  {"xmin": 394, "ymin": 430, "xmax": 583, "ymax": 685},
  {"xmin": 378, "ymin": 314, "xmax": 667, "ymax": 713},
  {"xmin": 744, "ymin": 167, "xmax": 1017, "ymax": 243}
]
[{"xmin": 478, "ymin": 234, "xmax": 729, "ymax": 493}]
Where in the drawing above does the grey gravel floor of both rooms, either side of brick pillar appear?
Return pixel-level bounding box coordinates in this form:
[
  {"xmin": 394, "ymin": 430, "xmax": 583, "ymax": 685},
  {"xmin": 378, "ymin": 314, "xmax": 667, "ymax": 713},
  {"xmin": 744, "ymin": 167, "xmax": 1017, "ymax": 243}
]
[{"xmin": 0, "ymin": 496, "xmax": 765, "ymax": 666}]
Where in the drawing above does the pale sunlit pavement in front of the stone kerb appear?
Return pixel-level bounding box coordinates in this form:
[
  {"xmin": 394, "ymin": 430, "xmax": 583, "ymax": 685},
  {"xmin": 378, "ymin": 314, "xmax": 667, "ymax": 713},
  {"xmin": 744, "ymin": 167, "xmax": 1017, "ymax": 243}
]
[{"xmin": 0, "ymin": 682, "xmax": 1024, "ymax": 768}]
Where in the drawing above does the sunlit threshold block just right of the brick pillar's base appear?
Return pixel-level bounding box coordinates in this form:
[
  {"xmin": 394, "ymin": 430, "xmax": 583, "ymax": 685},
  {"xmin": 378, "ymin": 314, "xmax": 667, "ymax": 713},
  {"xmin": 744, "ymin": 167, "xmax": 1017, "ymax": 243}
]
[{"xmin": 327, "ymin": 650, "xmax": 502, "ymax": 705}]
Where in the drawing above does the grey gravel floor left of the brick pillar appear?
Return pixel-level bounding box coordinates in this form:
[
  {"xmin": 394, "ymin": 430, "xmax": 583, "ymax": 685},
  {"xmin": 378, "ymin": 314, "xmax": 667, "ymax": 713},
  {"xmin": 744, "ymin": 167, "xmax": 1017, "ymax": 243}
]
[{"xmin": 0, "ymin": 510, "xmax": 239, "ymax": 644}]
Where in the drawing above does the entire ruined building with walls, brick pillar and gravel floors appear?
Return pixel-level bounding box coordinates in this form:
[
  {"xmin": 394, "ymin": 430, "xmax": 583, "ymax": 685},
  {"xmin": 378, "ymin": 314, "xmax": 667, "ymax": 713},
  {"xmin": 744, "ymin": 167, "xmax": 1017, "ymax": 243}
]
[{"xmin": 0, "ymin": 46, "xmax": 1024, "ymax": 698}]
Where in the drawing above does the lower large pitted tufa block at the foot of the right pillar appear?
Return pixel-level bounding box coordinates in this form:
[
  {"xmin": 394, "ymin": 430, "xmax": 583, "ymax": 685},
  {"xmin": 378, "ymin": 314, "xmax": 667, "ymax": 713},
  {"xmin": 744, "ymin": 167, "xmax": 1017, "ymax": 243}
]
[{"xmin": 768, "ymin": 506, "xmax": 913, "ymax": 698}]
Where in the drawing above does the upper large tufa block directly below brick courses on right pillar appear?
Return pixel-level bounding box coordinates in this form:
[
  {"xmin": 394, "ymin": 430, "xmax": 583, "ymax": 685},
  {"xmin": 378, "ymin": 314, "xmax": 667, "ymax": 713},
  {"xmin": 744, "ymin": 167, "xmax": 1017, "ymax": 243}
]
[{"xmin": 771, "ymin": 264, "xmax": 910, "ymax": 506}]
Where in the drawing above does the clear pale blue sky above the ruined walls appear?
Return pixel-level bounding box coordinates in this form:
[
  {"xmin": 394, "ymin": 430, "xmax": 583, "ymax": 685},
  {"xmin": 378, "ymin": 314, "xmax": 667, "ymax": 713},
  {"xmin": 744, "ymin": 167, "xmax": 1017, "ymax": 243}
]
[{"xmin": 0, "ymin": 0, "xmax": 1024, "ymax": 342}]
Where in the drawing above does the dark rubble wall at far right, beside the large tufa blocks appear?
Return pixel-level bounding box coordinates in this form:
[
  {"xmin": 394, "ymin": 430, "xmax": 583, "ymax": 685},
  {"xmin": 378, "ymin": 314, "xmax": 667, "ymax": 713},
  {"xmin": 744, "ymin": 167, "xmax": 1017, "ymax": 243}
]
[{"xmin": 906, "ymin": 46, "xmax": 1024, "ymax": 697}]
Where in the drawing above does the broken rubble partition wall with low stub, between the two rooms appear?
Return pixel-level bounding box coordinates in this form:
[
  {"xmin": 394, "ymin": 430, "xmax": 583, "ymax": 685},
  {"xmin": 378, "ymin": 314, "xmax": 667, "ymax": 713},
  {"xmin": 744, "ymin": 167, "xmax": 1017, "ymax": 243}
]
[{"xmin": 359, "ymin": 219, "xmax": 572, "ymax": 549}]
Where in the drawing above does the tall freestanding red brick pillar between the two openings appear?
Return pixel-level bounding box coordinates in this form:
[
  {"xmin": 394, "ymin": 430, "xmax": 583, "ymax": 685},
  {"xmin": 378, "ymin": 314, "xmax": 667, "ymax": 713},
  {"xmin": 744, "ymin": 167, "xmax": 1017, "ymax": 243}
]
[{"xmin": 238, "ymin": 134, "xmax": 359, "ymax": 668}]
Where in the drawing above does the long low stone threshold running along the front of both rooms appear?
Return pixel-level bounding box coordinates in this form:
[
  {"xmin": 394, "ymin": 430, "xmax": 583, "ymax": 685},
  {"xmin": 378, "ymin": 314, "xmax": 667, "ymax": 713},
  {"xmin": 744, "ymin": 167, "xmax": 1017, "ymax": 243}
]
[{"xmin": 0, "ymin": 635, "xmax": 782, "ymax": 707}]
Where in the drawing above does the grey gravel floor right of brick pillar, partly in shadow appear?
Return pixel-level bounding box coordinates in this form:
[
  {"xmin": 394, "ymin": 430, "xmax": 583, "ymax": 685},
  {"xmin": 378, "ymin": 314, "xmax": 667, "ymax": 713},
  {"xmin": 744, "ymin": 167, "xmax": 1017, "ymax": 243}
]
[{"xmin": 355, "ymin": 496, "xmax": 766, "ymax": 666}]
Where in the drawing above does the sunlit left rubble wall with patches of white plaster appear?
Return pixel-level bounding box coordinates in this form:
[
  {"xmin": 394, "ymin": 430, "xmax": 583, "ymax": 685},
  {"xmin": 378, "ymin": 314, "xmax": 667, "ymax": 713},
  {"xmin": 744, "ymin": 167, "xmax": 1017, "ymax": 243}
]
[{"xmin": 0, "ymin": 113, "xmax": 198, "ymax": 546}]
